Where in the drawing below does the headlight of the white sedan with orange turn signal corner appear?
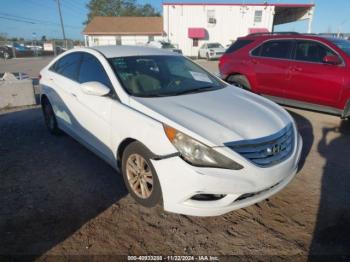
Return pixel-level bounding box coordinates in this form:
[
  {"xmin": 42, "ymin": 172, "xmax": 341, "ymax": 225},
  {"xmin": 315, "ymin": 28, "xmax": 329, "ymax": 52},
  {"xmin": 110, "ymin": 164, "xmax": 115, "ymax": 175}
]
[{"xmin": 163, "ymin": 125, "xmax": 243, "ymax": 170}]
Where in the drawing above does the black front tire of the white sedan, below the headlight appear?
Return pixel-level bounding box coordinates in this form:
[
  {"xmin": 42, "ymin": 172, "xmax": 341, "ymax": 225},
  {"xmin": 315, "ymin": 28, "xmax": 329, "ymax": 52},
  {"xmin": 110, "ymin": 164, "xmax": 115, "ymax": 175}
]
[{"xmin": 122, "ymin": 141, "xmax": 162, "ymax": 207}]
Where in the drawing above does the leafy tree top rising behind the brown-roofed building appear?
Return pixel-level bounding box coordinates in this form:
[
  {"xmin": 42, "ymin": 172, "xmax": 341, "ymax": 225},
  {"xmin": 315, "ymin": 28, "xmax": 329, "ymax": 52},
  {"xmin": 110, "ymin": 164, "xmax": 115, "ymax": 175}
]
[{"xmin": 84, "ymin": 0, "xmax": 160, "ymax": 24}]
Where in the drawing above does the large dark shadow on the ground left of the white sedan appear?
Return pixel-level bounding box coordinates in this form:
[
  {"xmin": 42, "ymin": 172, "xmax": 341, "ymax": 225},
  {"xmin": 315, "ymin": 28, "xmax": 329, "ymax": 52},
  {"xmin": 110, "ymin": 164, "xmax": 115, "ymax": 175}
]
[{"xmin": 0, "ymin": 108, "xmax": 127, "ymax": 257}]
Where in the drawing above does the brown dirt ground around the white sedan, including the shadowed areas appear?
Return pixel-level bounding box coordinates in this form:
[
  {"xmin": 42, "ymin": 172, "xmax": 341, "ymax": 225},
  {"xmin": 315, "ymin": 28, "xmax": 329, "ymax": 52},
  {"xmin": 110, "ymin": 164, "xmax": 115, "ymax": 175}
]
[{"xmin": 0, "ymin": 56, "xmax": 350, "ymax": 261}]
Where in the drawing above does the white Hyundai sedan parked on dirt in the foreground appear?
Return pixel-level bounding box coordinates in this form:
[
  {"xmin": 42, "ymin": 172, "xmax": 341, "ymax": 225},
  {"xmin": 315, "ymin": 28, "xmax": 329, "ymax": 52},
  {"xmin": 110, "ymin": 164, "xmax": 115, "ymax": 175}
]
[{"xmin": 40, "ymin": 46, "xmax": 302, "ymax": 216}]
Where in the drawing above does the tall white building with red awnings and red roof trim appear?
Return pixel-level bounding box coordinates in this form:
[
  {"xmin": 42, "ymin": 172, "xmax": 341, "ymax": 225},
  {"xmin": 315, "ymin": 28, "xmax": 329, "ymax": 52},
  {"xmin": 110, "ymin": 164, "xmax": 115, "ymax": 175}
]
[{"xmin": 163, "ymin": 3, "xmax": 314, "ymax": 56}]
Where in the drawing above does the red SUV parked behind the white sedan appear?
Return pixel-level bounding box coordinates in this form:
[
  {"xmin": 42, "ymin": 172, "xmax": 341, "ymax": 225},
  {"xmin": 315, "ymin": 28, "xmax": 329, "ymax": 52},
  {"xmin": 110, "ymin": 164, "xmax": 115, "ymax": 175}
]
[{"xmin": 219, "ymin": 33, "xmax": 350, "ymax": 118}]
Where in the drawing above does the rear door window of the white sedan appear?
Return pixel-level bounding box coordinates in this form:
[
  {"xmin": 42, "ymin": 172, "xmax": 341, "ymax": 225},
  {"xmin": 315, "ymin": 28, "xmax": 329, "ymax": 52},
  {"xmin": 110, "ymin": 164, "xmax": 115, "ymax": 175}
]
[{"xmin": 50, "ymin": 52, "xmax": 81, "ymax": 81}]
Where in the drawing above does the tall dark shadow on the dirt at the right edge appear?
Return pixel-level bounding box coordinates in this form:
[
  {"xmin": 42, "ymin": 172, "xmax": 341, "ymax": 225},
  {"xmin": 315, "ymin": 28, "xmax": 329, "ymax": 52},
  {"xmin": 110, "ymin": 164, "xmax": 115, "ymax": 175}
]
[{"xmin": 309, "ymin": 120, "xmax": 350, "ymax": 261}]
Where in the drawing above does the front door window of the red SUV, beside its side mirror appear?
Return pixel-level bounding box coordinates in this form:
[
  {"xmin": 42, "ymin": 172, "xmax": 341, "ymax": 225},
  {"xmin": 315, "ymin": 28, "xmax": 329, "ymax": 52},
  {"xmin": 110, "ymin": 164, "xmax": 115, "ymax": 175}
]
[{"xmin": 295, "ymin": 41, "xmax": 336, "ymax": 63}]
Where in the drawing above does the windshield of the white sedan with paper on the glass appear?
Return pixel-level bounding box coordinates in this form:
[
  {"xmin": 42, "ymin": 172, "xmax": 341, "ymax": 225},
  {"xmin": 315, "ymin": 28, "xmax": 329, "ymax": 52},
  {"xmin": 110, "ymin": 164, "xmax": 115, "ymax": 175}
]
[{"xmin": 109, "ymin": 55, "xmax": 226, "ymax": 97}]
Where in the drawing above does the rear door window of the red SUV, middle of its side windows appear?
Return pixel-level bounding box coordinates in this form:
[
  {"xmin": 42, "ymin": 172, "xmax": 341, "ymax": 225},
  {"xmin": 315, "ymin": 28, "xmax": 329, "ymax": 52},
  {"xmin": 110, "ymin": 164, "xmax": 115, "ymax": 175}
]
[{"xmin": 252, "ymin": 40, "xmax": 293, "ymax": 59}]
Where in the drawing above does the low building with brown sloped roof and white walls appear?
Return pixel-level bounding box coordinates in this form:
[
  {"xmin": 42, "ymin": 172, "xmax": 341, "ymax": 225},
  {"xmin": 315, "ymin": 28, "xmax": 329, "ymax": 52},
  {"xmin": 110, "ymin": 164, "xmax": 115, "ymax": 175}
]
[{"xmin": 83, "ymin": 16, "xmax": 164, "ymax": 46}]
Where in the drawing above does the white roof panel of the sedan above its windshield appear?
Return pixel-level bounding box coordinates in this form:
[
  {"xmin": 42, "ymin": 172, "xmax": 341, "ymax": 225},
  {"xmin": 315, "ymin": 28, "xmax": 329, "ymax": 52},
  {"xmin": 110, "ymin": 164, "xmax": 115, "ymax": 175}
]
[{"xmin": 90, "ymin": 45, "xmax": 181, "ymax": 58}]
